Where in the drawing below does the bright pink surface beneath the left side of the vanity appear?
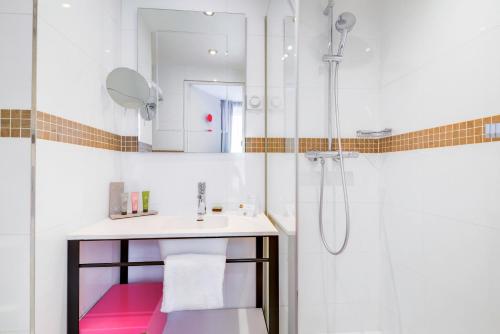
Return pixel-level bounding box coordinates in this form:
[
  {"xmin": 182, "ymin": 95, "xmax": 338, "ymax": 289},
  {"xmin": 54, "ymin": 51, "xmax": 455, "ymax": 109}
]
[{"xmin": 80, "ymin": 282, "xmax": 167, "ymax": 334}]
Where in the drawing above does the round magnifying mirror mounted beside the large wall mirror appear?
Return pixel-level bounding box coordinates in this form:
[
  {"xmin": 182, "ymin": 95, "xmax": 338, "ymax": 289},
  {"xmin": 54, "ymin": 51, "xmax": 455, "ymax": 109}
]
[{"xmin": 106, "ymin": 67, "xmax": 150, "ymax": 109}]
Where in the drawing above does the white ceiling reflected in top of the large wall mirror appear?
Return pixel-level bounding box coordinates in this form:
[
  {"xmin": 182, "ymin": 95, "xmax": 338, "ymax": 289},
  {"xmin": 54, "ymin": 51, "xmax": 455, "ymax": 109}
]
[{"xmin": 139, "ymin": 9, "xmax": 246, "ymax": 70}]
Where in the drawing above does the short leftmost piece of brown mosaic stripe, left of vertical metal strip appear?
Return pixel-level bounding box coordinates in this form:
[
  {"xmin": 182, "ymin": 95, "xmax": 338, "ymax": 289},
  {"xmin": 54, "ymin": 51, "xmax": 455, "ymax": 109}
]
[{"xmin": 0, "ymin": 109, "xmax": 31, "ymax": 138}]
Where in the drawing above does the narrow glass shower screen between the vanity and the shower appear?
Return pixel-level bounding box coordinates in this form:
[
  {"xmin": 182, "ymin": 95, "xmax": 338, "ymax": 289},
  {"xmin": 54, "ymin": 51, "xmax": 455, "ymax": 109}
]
[{"xmin": 266, "ymin": 0, "xmax": 297, "ymax": 334}]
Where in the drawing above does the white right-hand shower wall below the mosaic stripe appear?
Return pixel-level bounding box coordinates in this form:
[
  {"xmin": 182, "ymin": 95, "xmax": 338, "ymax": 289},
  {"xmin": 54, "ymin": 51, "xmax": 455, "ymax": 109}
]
[{"xmin": 382, "ymin": 143, "xmax": 500, "ymax": 333}]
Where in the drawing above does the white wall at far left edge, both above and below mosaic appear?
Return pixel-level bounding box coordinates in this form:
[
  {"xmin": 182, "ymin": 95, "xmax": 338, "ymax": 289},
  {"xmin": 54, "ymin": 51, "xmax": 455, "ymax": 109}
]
[{"xmin": 0, "ymin": 0, "xmax": 33, "ymax": 333}]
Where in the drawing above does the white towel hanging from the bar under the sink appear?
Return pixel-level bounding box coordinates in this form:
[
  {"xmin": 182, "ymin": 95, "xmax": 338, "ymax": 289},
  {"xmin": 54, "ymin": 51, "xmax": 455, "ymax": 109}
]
[{"xmin": 161, "ymin": 254, "xmax": 226, "ymax": 313}]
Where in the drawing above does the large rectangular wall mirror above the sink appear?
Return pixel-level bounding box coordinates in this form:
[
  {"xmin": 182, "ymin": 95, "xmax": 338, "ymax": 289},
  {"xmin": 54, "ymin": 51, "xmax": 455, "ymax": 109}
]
[{"xmin": 137, "ymin": 9, "xmax": 247, "ymax": 153}]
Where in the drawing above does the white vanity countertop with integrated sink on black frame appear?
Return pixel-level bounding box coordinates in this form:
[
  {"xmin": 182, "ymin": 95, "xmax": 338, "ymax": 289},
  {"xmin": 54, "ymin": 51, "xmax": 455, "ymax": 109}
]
[{"xmin": 67, "ymin": 214, "xmax": 278, "ymax": 240}]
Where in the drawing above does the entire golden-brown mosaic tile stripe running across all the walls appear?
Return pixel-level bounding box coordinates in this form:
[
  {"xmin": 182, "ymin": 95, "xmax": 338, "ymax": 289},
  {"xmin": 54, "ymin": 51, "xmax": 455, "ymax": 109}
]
[{"xmin": 0, "ymin": 109, "xmax": 500, "ymax": 153}]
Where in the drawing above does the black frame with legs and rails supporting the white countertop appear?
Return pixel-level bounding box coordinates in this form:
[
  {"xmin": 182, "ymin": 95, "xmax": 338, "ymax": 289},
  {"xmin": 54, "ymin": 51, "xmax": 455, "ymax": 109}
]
[{"xmin": 67, "ymin": 235, "xmax": 279, "ymax": 334}]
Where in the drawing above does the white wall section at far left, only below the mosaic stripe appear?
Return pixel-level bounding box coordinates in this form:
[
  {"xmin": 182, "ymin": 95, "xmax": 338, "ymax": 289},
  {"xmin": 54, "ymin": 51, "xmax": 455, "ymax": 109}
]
[{"xmin": 0, "ymin": 140, "xmax": 31, "ymax": 333}]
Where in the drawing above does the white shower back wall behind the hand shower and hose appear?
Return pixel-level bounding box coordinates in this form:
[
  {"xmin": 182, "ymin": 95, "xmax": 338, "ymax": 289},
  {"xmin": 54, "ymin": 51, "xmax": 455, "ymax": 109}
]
[{"xmin": 297, "ymin": 0, "xmax": 380, "ymax": 334}]
